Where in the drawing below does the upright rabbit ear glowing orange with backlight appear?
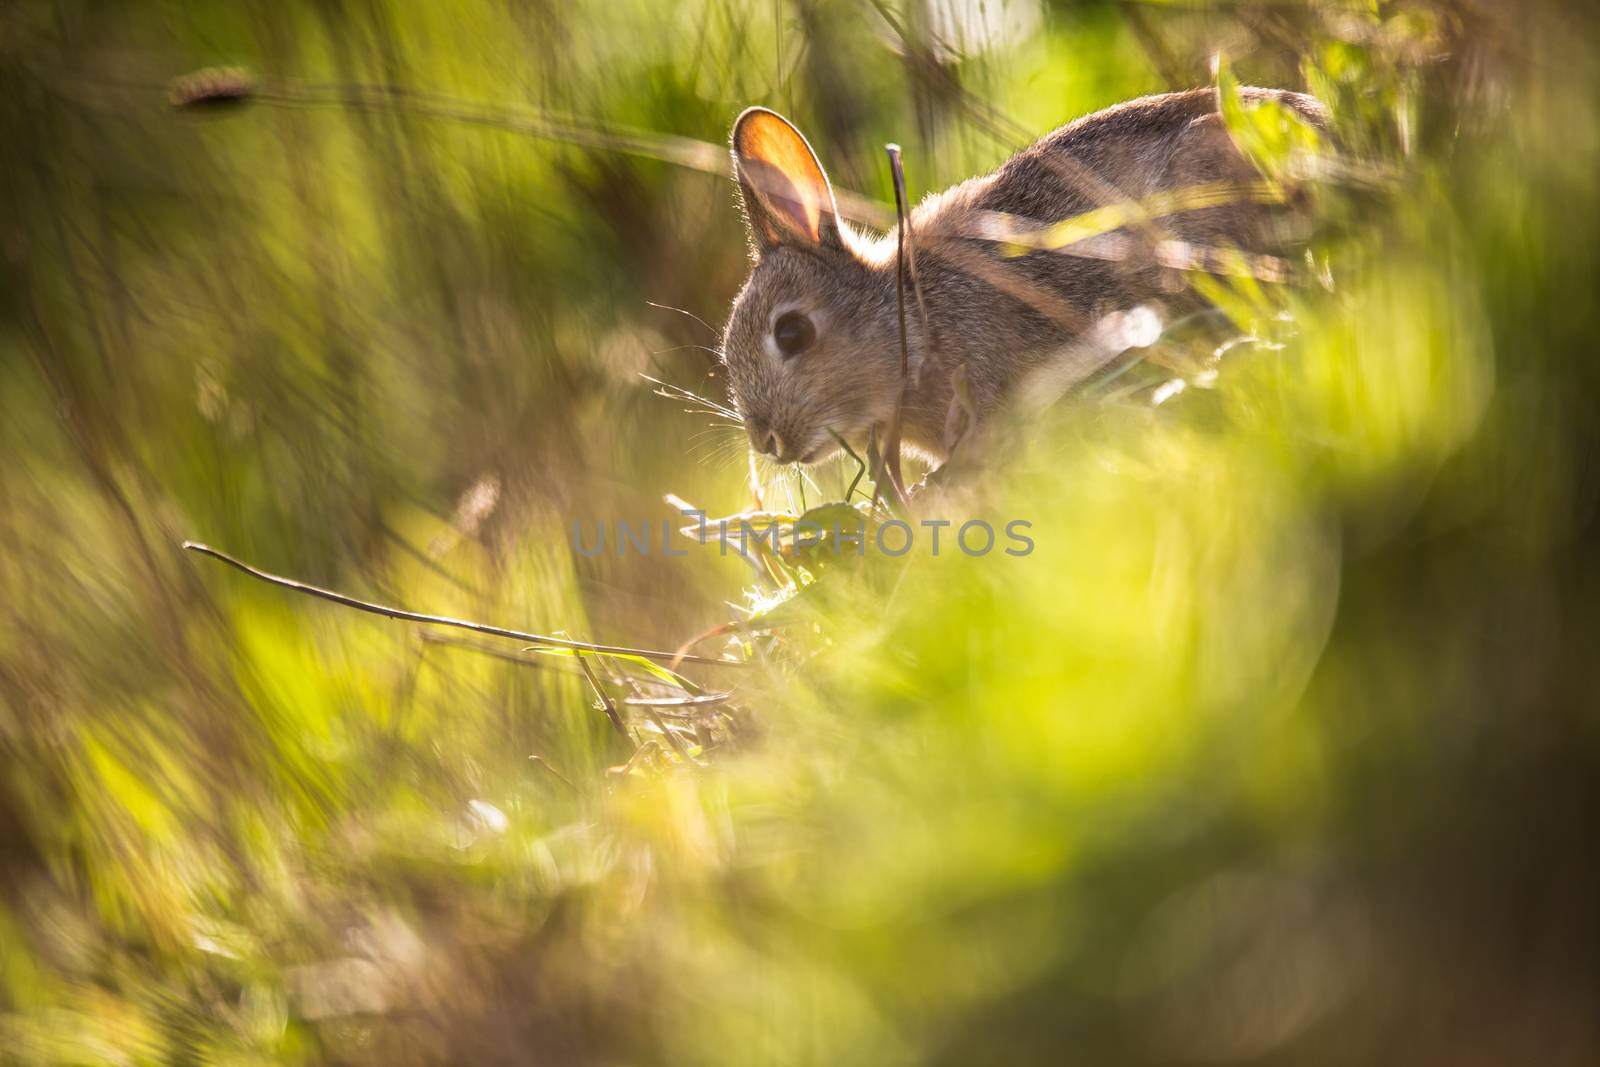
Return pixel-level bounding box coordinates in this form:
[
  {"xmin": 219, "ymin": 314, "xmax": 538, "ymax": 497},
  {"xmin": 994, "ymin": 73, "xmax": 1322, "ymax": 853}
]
[{"xmin": 733, "ymin": 107, "xmax": 845, "ymax": 253}]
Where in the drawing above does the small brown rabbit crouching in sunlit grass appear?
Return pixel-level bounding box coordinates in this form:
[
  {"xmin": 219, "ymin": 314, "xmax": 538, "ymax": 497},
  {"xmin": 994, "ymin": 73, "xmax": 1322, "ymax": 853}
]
[{"xmin": 722, "ymin": 88, "xmax": 1325, "ymax": 464}]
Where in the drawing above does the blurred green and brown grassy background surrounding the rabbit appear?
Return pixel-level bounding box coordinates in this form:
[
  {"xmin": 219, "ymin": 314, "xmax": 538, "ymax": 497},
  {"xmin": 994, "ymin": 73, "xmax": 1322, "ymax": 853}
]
[{"xmin": 0, "ymin": 0, "xmax": 1600, "ymax": 1067}]
